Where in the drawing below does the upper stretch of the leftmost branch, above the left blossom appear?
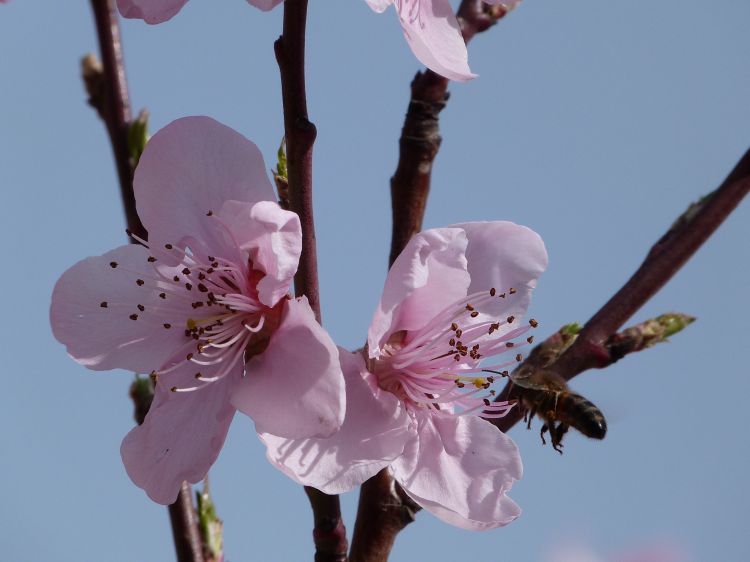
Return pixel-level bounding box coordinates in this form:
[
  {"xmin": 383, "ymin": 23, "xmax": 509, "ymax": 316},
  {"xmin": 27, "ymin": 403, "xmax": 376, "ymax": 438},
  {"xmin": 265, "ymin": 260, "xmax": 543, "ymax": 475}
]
[{"xmin": 84, "ymin": 0, "xmax": 146, "ymax": 239}]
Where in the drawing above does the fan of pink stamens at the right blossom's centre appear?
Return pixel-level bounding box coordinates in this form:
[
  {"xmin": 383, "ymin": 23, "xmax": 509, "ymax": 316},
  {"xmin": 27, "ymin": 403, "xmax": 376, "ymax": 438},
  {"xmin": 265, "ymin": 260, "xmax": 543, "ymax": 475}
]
[{"xmin": 370, "ymin": 288, "xmax": 538, "ymax": 418}]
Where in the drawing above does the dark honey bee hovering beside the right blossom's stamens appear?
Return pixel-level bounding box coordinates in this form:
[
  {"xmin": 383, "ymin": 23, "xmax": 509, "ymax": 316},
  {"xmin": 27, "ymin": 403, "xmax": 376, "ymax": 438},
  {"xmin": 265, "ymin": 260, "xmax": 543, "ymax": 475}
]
[{"xmin": 496, "ymin": 367, "xmax": 607, "ymax": 454}]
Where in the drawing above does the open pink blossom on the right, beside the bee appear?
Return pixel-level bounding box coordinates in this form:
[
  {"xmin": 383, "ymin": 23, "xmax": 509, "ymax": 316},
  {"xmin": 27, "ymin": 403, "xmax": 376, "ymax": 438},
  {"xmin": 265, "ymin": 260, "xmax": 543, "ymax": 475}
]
[{"xmin": 261, "ymin": 222, "xmax": 547, "ymax": 530}]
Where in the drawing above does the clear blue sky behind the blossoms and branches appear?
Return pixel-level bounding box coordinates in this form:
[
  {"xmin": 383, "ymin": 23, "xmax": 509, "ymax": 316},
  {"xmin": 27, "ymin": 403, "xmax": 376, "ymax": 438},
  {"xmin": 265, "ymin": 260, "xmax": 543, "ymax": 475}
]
[{"xmin": 0, "ymin": 0, "xmax": 750, "ymax": 562}]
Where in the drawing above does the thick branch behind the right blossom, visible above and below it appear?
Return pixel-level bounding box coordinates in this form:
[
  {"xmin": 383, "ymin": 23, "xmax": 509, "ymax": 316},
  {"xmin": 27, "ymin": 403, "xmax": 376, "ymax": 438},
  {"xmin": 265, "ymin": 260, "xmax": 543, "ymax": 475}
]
[{"xmin": 352, "ymin": 0, "xmax": 507, "ymax": 562}]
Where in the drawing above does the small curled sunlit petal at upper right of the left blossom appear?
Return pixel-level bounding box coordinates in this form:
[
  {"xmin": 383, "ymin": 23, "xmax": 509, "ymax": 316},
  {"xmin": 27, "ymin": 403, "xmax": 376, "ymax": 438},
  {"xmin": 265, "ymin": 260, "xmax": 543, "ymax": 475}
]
[{"xmin": 219, "ymin": 201, "xmax": 302, "ymax": 306}]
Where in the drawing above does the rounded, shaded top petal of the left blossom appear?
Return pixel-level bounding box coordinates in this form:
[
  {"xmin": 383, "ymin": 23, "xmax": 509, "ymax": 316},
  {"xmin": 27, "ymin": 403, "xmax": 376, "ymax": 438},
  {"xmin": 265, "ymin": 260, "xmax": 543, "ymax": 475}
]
[{"xmin": 133, "ymin": 117, "xmax": 275, "ymax": 248}]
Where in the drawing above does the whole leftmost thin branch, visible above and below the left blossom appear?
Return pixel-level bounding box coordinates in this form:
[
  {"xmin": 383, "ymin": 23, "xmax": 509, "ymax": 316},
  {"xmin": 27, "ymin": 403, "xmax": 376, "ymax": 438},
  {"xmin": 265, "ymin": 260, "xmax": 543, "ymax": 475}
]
[{"xmin": 84, "ymin": 0, "xmax": 203, "ymax": 562}]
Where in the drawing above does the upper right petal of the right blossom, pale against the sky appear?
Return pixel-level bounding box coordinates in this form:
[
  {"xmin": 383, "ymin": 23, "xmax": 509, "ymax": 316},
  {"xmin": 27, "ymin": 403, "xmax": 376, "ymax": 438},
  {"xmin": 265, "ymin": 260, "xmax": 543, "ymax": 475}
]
[{"xmin": 452, "ymin": 221, "xmax": 547, "ymax": 317}]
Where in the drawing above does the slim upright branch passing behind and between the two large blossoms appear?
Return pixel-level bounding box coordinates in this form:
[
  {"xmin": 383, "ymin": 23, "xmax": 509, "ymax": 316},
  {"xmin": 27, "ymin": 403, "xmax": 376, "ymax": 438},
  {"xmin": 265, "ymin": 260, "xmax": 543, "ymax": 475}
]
[{"xmin": 274, "ymin": 0, "xmax": 349, "ymax": 562}]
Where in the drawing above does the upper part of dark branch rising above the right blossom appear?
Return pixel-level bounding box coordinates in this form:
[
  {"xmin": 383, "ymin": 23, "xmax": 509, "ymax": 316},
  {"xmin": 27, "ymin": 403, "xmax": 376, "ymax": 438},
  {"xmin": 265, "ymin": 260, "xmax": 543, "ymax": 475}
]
[{"xmin": 390, "ymin": 0, "xmax": 507, "ymax": 263}]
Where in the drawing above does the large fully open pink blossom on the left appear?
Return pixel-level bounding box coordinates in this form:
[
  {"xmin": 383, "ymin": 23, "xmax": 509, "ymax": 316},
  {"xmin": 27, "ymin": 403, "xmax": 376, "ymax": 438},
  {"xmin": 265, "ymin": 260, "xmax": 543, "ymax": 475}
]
[{"xmin": 50, "ymin": 117, "xmax": 345, "ymax": 504}]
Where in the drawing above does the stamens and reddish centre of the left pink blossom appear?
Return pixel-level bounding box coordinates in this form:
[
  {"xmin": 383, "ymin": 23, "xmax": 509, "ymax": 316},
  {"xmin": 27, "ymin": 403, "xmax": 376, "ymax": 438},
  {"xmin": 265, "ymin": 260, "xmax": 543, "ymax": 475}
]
[{"xmin": 110, "ymin": 223, "xmax": 281, "ymax": 392}]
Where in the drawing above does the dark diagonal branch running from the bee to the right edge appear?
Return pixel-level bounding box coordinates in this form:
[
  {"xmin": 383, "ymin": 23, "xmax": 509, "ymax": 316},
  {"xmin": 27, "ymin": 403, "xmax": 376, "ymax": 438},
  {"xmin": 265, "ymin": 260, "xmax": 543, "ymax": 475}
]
[{"xmin": 493, "ymin": 150, "xmax": 750, "ymax": 431}]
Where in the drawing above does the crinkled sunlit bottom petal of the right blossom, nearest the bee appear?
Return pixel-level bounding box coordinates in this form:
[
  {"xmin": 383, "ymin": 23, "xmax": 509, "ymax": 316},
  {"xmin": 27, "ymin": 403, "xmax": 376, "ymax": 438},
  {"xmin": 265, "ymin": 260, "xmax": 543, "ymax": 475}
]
[{"xmin": 391, "ymin": 411, "xmax": 522, "ymax": 530}]
